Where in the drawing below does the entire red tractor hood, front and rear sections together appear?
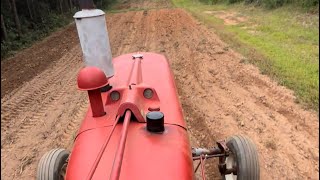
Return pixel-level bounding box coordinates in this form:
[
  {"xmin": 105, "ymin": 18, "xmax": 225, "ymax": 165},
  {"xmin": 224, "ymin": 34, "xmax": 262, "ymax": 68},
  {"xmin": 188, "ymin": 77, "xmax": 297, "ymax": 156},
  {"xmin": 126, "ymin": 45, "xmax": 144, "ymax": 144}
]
[{"xmin": 66, "ymin": 53, "xmax": 194, "ymax": 180}]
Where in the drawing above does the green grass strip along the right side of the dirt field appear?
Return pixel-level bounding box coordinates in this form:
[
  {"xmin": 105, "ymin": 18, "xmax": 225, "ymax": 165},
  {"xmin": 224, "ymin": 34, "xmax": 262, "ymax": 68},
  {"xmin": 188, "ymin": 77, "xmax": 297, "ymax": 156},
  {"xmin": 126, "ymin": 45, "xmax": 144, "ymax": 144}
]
[{"xmin": 172, "ymin": 0, "xmax": 319, "ymax": 111}]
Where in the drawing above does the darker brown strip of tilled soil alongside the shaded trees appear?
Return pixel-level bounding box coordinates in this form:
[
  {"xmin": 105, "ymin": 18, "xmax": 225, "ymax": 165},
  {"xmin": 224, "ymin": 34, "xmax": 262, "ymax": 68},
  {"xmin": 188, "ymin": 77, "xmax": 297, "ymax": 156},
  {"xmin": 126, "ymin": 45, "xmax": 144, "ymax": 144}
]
[{"xmin": 1, "ymin": 23, "xmax": 78, "ymax": 98}]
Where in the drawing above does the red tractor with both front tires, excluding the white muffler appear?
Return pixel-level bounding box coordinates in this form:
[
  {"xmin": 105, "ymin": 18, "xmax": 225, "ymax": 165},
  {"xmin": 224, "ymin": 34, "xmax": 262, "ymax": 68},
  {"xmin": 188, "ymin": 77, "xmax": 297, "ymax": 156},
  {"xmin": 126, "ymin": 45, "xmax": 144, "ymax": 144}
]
[{"xmin": 37, "ymin": 53, "xmax": 260, "ymax": 180}]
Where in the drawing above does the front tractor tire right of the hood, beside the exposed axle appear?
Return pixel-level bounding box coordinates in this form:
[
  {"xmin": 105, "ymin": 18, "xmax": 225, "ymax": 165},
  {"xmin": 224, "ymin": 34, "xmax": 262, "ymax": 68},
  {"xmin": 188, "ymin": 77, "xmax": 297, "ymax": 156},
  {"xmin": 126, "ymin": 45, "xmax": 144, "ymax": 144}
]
[{"xmin": 222, "ymin": 135, "xmax": 260, "ymax": 180}]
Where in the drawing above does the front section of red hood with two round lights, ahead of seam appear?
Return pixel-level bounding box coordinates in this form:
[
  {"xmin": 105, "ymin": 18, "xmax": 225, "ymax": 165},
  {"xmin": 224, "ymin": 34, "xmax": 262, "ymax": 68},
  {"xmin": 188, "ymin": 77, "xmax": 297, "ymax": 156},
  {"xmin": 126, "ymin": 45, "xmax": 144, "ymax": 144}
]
[{"xmin": 78, "ymin": 53, "xmax": 186, "ymax": 134}]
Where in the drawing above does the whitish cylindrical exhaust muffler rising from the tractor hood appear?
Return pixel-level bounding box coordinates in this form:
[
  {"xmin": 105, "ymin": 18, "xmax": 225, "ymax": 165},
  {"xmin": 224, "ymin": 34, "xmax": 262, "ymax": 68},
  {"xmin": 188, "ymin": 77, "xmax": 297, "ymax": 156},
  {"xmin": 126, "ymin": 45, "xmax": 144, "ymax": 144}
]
[{"xmin": 73, "ymin": 0, "xmax": 114, "ymax": 78}]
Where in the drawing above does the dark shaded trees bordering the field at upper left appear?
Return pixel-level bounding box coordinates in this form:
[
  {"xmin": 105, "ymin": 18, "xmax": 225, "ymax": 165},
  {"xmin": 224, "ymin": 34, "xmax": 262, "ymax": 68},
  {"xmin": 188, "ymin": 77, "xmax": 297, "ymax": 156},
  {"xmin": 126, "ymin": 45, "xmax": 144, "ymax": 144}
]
[{"xmin": 1, "ymin": 0, "xmax": 112, "ymax": 59}]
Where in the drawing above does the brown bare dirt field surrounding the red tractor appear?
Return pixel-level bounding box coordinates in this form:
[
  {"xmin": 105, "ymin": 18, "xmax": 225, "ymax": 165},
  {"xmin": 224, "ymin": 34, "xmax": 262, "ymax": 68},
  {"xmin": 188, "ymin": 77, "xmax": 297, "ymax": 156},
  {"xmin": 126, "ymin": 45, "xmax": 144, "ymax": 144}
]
[{"xmin": 1, "ymin": 1, "xmax": 319, "ymax": 180}]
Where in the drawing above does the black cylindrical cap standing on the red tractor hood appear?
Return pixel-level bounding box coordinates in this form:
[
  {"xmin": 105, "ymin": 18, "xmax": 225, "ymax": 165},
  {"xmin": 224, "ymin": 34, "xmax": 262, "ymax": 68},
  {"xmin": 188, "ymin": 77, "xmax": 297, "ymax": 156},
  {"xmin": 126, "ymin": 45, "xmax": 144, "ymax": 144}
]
[{"xmin": 147, "ymin": 111, "xmax": 164, "ymax": 132}]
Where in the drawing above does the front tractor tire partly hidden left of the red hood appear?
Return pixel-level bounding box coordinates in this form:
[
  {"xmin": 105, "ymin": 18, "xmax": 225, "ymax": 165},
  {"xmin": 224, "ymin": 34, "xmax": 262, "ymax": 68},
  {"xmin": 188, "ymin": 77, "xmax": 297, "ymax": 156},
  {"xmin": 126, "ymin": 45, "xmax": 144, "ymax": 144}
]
[{"xmin": 37, "ymin": 149, "xmax": 70, "ymax": 180}]
